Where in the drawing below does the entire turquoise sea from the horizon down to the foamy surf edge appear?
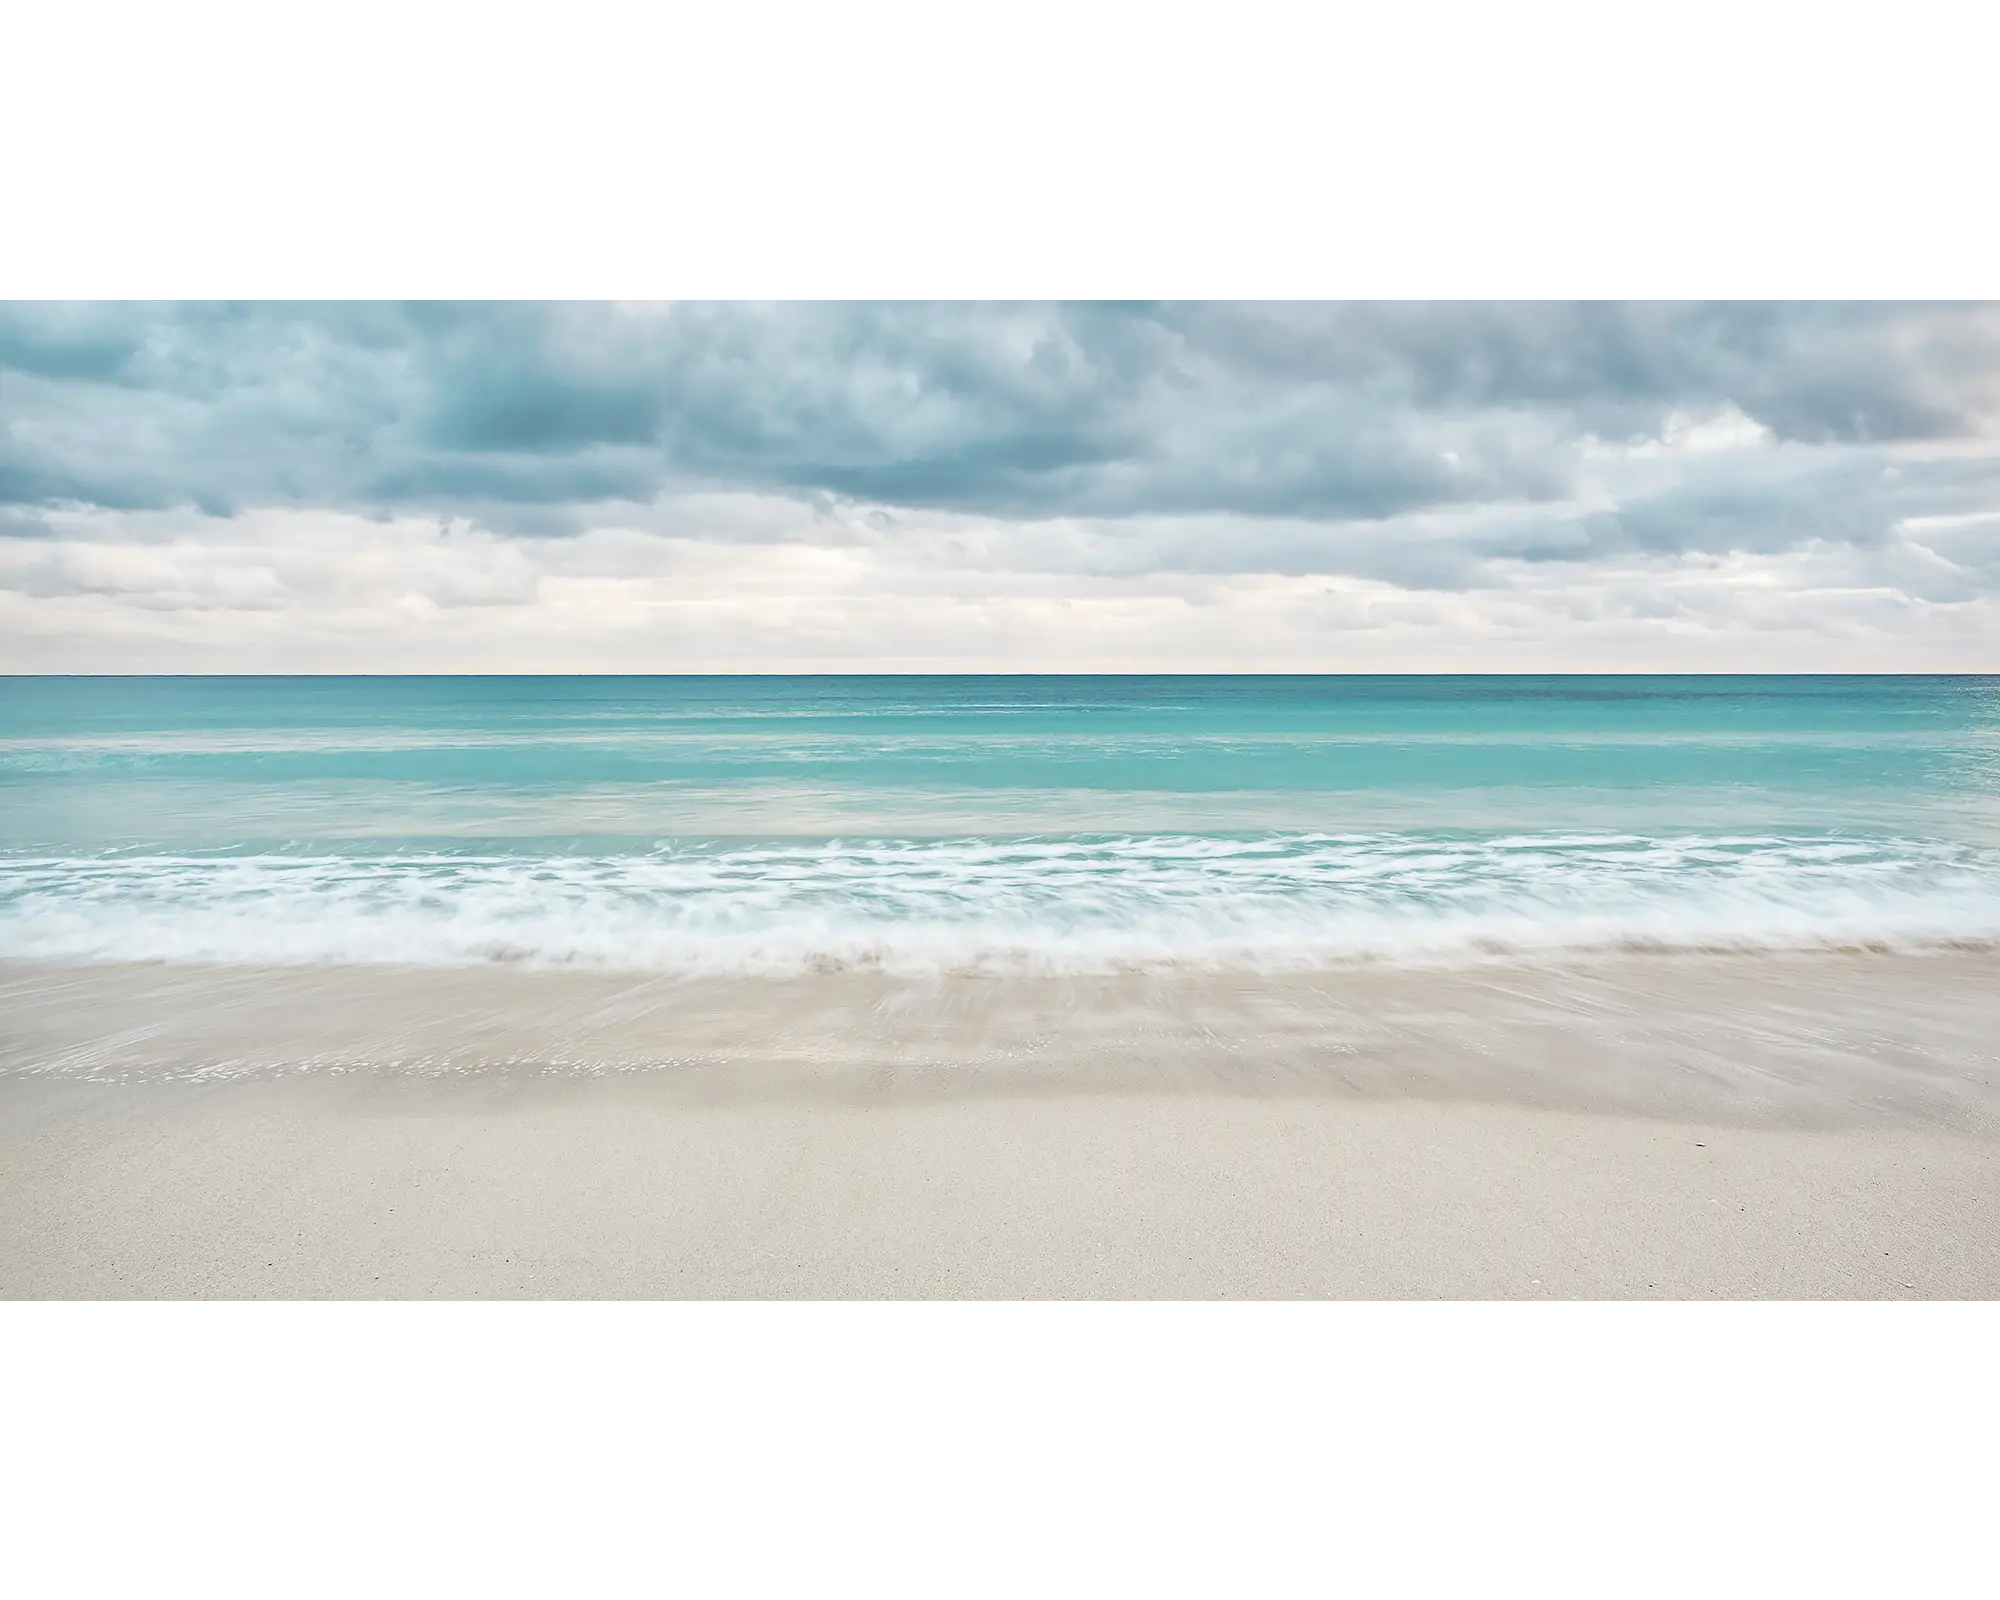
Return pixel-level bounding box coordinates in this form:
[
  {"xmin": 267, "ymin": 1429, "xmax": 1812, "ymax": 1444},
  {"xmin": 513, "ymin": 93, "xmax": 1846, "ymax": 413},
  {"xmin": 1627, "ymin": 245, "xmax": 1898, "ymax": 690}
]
[{"xmin": 0, "ymin": 676, "xmax": 2000, "ymax": 972}]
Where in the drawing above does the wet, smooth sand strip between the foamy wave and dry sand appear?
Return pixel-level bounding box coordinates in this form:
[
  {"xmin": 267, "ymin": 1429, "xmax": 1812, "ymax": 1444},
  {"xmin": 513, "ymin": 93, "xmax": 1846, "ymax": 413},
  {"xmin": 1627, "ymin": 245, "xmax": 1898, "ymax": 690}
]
[{"xmin": 0, "ymin": 952, "xmax": 2000, "ymax": 1134}]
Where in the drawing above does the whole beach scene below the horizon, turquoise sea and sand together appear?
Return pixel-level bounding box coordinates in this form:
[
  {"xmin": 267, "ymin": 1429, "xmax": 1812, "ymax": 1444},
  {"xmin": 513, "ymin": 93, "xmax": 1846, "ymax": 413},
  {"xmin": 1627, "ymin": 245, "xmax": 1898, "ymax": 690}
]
[{"xmin": 0, "ymin": 676, "xmax": 2000, "ymax": 1302}]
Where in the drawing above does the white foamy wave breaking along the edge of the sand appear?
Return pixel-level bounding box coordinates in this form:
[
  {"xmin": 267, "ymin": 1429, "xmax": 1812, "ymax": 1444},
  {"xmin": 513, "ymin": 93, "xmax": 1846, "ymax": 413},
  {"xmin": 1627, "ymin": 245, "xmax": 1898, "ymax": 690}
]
[{"xmin": 0, "ymin": 834, "xmax": 2000, "ymax": 974}]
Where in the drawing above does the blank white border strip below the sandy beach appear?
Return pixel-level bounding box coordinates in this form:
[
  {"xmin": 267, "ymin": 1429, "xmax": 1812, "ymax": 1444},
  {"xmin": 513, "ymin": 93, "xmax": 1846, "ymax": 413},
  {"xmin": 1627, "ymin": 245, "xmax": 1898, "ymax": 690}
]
[{"xmin": 0, "ymin": 1308, "xmax": 2000, "ymax": 1596}]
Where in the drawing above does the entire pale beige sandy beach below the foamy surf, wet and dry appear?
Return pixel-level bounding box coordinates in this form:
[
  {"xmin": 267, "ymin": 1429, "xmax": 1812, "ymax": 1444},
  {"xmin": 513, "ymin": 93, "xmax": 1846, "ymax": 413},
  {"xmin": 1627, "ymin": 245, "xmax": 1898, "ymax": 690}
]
[{"xmin": 0, "ymin": 952, "xmax": 2000, "ymax": 1300}]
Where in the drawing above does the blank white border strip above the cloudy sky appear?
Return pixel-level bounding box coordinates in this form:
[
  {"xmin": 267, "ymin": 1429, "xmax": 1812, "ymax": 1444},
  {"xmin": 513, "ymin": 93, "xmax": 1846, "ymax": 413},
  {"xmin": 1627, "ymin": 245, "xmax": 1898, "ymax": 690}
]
[{"xmin": 0, "ymin": 0, "xmax": 2000, "ymax": 294}]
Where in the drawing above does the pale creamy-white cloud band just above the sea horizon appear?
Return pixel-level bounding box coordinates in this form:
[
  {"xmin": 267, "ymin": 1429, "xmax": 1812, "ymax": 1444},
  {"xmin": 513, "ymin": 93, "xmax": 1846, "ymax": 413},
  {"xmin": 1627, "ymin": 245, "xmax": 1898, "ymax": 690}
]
[{"xmin": 0, "ymin": 502, "xmax": 2000, "ymax": 672}]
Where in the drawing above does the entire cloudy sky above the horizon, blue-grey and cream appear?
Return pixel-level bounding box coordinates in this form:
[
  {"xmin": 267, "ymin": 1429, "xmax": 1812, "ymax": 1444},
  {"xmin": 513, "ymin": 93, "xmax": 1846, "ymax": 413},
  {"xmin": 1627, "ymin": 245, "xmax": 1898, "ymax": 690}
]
[{"xmin": 0, "ymin": 300, "xmax": 2000, "ymax": 672}]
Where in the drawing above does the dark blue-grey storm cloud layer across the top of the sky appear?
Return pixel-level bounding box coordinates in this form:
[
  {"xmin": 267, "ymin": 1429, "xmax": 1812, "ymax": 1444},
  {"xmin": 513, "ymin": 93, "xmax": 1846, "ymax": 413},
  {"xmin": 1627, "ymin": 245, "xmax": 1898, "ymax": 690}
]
[{"xmin": 0, "ymin": 300, "xmax": 2000, "ymax": 564}]
